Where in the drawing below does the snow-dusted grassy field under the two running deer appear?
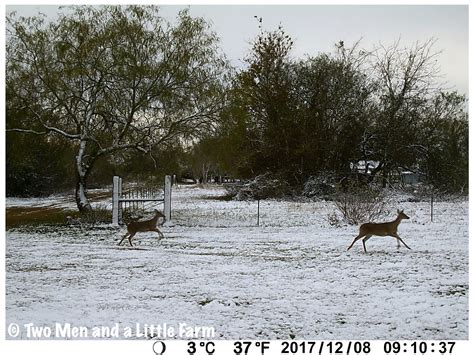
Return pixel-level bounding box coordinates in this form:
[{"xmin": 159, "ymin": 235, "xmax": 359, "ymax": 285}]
[{"xmin": 6, "ymin": 186, "xmax": 469, "ymax": 339}]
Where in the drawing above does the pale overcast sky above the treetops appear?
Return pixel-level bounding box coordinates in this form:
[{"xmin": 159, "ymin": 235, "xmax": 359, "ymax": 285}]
[{"xmin": 6, "ymin": 5, "xmax": 469, "ymax": 94}]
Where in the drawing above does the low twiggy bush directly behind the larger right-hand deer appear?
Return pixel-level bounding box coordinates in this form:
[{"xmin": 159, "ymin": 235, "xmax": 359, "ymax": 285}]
[{"xmin": 331, "ymin": 188, "xmax": 387, "ymax": 225}]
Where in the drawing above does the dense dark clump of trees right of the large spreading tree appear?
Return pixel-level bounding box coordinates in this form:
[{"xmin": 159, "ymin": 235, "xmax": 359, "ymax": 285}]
[{"xmin": 211, "ymin": 28, "xmax": 468, "ymax": 192}]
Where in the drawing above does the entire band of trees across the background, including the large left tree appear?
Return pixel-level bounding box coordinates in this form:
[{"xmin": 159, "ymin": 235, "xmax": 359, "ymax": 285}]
[{"xmin": 6, "ymin": 6, "xmax": 468, "ymax": 211}]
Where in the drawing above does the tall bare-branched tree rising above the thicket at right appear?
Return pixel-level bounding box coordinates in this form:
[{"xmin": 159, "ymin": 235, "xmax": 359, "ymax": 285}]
[{"xmin": 361, "ymin": 39, "xmax": 440, "ymax": 183}]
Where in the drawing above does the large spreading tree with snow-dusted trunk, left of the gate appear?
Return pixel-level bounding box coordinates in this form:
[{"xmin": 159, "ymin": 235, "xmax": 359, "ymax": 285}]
[{"xmin": 6, "ymin": 6, "xmax": 227, "ymax": 211}]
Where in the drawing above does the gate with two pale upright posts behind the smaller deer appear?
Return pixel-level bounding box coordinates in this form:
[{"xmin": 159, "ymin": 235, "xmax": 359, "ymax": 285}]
[{"xmin": 112, "ymin": 175, "xmax": 171, "ymax": 226}]
